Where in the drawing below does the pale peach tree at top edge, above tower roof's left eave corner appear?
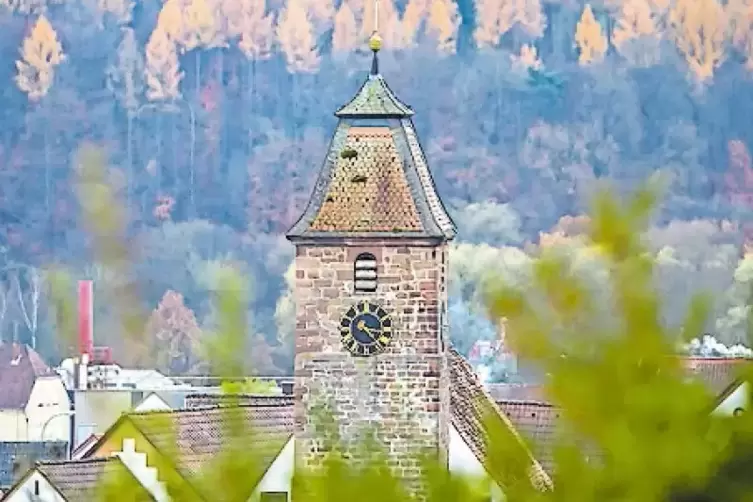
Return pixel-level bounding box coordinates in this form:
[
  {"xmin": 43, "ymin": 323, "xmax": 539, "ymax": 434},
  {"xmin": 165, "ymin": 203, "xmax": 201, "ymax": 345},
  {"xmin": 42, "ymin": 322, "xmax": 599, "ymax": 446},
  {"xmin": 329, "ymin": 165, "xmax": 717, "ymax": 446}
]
[{"xmin": 277, "ymin": 0, "xmax": 321, "ymax": 73}]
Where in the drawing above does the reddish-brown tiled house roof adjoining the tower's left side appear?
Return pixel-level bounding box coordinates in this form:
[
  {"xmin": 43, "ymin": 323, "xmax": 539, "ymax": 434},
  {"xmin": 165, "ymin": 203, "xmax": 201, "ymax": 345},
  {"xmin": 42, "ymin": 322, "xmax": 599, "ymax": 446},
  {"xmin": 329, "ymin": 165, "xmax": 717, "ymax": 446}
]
[{"xmin": 128, "ymin": 403, "xmax": 293, "ymax": 494}]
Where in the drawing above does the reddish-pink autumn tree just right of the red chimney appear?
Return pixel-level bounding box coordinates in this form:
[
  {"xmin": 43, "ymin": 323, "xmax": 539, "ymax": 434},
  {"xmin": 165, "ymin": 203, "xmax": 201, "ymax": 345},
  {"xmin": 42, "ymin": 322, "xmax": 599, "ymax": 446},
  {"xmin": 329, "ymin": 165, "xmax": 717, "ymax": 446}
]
[{"xmin": 144, "ymin": 290, "xmax": 201, "ymax": 375}]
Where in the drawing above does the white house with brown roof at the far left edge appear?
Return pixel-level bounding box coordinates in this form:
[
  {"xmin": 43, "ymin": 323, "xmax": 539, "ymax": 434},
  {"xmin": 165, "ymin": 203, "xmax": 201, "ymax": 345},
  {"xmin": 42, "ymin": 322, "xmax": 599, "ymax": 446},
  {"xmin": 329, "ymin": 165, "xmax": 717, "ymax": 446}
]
[{"xmin": 0, "ymin": 343, "xmax": 71, "ymax": 442}]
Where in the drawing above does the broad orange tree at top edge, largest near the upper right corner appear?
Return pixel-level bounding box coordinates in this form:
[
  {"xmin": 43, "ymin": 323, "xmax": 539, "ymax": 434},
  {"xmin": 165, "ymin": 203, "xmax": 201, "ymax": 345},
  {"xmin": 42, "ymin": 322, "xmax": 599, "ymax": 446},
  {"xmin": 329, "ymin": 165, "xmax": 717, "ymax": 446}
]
[{"xmin": 669, "ymin": 0, "xmax": 727, "ymax": 82}]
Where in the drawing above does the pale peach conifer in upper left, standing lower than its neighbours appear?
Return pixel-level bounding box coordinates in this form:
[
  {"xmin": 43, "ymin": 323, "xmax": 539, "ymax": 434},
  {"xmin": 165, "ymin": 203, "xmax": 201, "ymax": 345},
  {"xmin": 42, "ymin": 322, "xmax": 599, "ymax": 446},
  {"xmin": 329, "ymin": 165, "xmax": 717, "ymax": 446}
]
[{"xmin": 144, "ymin": 26, "xmax": 183, "ymax": 101}]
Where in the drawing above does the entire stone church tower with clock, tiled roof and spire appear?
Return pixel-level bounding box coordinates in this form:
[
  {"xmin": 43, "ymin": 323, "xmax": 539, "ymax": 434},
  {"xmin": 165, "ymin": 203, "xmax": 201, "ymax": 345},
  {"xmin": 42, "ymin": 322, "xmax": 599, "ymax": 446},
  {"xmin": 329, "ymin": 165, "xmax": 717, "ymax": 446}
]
[{"xmin": 287, "ymin": 24, "xmax": 455, "ymax": 481}]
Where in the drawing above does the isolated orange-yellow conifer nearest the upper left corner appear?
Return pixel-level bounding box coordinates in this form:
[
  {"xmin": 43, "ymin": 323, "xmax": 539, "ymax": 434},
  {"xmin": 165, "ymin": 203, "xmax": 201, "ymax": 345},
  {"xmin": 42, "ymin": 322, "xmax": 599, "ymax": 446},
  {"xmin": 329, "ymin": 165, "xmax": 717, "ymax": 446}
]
[{"xmin": 16, "ymin": 15, "xmax": 65, "ymax": 101}]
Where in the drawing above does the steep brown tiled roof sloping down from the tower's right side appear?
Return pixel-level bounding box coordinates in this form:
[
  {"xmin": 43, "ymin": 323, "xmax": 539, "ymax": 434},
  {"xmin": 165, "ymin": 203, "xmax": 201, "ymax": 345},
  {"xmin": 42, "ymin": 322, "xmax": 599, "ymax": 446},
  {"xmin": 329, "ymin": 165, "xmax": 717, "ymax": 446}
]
[{"xmin": 449, "ymin": 349, "xmax": 552, "ymax": 489}]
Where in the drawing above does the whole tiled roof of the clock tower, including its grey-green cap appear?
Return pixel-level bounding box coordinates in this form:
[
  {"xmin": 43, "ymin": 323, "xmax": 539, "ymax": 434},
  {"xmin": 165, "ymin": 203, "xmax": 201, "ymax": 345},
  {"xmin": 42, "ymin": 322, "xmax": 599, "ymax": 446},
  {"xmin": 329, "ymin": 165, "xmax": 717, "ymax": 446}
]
[{"xmin": 287, "ymin": 53, "xmax": 456, "ymax": 240}]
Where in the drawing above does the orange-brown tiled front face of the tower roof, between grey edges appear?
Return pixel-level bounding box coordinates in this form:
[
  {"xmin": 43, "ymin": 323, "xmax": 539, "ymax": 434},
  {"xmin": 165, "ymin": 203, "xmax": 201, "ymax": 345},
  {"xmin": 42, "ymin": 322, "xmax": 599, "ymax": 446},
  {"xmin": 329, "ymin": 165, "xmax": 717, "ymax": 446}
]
[{"xmin": 311, "ymin": 127, "xmax": 422, "ymax": 232}]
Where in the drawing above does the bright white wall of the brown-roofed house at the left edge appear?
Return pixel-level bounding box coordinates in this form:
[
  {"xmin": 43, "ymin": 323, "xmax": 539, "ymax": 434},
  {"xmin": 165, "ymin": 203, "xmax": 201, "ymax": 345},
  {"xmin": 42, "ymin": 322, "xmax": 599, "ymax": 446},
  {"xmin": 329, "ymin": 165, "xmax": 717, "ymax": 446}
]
[{"xmin": 25, "ymin": 375, "xmax": 71, "ymax": 441}]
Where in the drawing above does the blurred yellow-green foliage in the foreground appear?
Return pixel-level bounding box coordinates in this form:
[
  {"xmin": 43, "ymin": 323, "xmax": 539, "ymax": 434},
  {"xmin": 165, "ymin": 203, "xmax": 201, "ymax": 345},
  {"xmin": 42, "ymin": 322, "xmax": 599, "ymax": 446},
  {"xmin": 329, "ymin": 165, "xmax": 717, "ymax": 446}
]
[{"xmin": 45, "ymin": 144, "xmax": 753, "ymax": 502}]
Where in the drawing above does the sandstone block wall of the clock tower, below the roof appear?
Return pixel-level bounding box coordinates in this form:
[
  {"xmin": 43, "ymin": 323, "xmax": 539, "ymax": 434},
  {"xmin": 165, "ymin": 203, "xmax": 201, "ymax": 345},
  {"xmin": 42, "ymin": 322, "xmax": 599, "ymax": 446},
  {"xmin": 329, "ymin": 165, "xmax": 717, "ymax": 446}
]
[{"xmin": 295, "ymin": 242, "xmax": 450, "ymax": 481}]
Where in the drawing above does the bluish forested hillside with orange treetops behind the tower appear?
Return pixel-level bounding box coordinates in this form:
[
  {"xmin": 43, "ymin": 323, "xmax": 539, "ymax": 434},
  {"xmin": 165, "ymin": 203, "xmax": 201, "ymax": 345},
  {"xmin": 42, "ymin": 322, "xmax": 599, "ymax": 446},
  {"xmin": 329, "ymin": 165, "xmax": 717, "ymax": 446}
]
[{"xmin": 0, "ymin": 0, "xmax": 753, "ymax": 373}]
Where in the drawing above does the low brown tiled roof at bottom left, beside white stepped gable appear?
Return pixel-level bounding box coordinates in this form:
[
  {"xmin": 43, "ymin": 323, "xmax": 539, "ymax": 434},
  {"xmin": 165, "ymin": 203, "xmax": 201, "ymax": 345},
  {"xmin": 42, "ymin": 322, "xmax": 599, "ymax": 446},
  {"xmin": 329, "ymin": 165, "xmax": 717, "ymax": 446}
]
[{"xmin": 36, "ymin": 457, "xmax": 154, "ymax": 502}]
